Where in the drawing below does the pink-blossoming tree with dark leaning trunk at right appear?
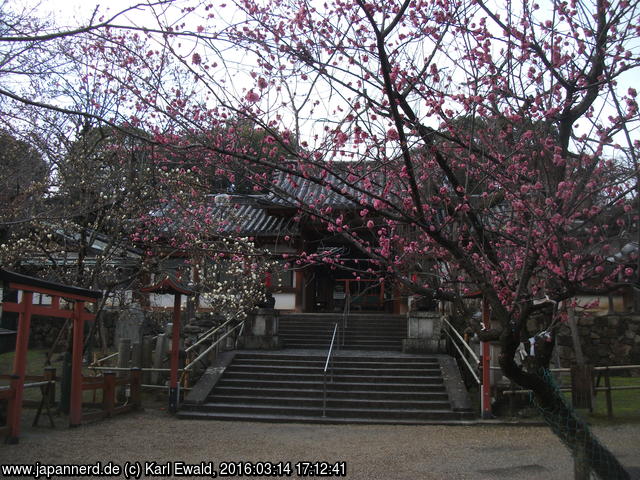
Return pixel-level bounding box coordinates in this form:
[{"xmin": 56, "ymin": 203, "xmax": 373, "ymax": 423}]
[{"xmin": 0, "ymin": 0, "xmax": 640, "ymax": 478}]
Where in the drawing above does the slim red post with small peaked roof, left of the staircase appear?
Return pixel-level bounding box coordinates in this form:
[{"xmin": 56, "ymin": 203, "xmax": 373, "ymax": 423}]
[{"xmin": 140, "ymin": 273, "xmax": 196, "ymax": 413}]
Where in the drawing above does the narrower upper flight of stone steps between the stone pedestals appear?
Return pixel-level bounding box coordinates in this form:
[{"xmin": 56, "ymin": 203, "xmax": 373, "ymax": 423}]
[{"xmin": 278, "ymin": 313, "xmax": 407, "ymax": 351}]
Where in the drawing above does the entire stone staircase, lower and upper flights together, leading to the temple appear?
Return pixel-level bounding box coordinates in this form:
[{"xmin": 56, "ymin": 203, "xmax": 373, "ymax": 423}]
[{"xmin": 178, "ymin": 314, "xmax": 473, "ymax": 424}]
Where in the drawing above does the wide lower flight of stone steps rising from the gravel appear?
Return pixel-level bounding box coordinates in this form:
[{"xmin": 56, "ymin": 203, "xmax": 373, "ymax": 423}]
[{"xmin": 179, "ymin": 350, "xmax": 473, "ymax": 424}]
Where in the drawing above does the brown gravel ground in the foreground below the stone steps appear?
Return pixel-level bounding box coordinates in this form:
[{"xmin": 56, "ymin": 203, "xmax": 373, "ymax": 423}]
[{"xmin": 0, "ymin": 408, "xmax": 640, "ymax": 480}]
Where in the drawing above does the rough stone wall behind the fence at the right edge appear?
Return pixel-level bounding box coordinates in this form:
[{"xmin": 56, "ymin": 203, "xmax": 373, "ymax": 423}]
[{"xmin": 558, "ymin": 313, "xmax": 640, "ymax": 366}]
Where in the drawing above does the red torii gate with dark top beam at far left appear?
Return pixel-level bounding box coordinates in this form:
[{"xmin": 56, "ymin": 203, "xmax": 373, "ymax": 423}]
[{"xmin": 0, "ymin": 269, "xmax": 102, "ymax": 443}]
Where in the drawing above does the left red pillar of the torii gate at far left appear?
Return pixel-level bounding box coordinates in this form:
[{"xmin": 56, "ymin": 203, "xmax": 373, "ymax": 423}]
[{"xmin": 7, "ymin": 291, "xmax": 33, "ymax": 443}]
